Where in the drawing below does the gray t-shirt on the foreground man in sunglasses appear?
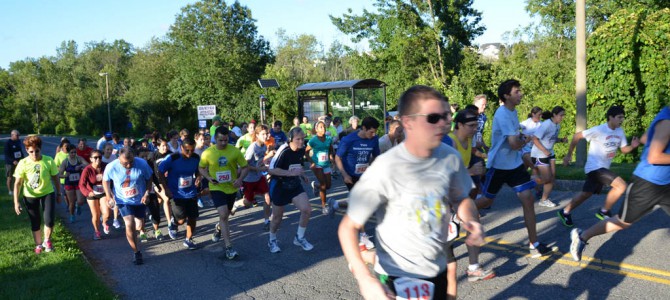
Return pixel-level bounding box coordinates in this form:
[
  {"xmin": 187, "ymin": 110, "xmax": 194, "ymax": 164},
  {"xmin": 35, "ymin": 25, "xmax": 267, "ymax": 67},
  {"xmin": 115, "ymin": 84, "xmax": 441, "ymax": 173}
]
[{"xmin": 347, "ymin": 143, "xmax": 472, "ymax": 278}]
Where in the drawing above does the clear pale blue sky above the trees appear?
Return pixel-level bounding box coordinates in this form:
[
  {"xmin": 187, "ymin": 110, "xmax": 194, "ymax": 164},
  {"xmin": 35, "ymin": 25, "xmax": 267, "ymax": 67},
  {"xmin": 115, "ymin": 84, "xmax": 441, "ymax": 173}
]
[{"xmin": 0, "ymin": 0, "xmax": 532, "ymax": 69}]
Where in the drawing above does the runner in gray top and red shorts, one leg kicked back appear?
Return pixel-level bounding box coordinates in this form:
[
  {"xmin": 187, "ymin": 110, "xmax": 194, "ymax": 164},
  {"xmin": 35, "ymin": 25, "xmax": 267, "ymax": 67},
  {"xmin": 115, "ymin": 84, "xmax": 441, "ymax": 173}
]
[{"xmin": 231, "ymin": 125, "xmax": 272, "ymax": 230}]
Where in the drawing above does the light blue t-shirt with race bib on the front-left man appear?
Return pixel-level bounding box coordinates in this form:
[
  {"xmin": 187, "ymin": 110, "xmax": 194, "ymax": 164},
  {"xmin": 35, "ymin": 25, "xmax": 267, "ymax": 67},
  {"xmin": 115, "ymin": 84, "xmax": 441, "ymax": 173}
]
[{"xmin": 102, "ymin": 157, "xmax": 153, "ymax": 205}]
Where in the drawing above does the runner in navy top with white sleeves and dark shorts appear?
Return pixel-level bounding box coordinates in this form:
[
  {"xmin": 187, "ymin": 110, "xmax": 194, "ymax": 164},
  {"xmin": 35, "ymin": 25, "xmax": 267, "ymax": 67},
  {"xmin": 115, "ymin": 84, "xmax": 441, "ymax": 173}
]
[{"xmin": 268, "ymin": 127, "xmax": 314, "ymax": 253}]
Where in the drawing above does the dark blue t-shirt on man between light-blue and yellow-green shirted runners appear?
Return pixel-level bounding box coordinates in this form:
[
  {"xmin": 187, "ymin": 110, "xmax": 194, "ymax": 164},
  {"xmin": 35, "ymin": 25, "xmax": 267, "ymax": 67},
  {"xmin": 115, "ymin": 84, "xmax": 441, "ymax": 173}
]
[{"xmin": 158, "ymin": 153, "xmax": 200, "ymax": 199}]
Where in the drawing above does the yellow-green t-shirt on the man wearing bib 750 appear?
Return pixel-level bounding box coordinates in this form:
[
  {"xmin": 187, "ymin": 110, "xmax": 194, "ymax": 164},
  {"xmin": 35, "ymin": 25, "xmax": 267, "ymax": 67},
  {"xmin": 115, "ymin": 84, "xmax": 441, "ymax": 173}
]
[{"xmin": 198, "ymin": 145, "xmax": 252, "ymax": 194}]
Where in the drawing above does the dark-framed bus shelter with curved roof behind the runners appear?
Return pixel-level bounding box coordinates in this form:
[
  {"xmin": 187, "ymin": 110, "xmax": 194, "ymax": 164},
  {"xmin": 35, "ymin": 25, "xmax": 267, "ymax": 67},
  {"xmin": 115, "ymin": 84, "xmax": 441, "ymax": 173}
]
[{"xmin": 296, "ymin": 79, "xmax": 386, "ymax": 130}]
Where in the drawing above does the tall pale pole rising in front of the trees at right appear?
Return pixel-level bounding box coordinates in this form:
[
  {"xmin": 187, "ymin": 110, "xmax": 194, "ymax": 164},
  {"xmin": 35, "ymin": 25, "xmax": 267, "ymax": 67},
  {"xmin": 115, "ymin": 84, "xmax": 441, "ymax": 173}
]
[{"xmin": 575, "ymin": 0, "xmax": 586, "ymax": 167}]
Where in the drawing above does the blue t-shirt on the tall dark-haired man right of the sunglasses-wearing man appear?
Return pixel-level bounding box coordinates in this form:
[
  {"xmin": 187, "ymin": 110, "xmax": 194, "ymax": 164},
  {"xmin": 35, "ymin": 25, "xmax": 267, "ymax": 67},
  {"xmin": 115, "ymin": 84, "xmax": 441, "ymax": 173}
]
[{"xmin": 486, "ymin": 105, "xmax": 523, "ymax": 170}]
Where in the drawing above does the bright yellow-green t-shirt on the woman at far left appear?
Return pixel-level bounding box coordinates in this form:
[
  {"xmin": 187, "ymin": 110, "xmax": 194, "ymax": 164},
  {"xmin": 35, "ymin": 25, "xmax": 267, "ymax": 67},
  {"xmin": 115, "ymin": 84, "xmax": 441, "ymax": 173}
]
[{"xmin": 14, "ymin": 155, "xmax": 58, "ymax": 198}]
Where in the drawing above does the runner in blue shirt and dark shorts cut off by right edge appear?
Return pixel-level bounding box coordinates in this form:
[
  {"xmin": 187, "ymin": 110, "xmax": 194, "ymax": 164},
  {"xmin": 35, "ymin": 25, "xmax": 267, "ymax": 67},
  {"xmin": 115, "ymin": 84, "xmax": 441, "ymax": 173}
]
[{"xmin": 570, "ymin": 105, "xmax": 670, "ymax": 261}]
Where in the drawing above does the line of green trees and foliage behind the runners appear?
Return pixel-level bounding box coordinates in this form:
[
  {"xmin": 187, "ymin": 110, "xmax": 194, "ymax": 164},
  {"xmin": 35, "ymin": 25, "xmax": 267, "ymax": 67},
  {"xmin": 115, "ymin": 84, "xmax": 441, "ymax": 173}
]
[{"xmin": 0, "ymin": 0, "xmax": 670, "ymax": 161}]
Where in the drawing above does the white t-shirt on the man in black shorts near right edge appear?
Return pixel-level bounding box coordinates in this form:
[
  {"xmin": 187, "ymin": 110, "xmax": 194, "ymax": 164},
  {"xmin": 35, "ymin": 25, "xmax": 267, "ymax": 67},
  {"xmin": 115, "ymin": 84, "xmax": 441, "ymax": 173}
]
[{"xmin": 582, "ymin": 123, "xmax": 628, "ymax": 174}]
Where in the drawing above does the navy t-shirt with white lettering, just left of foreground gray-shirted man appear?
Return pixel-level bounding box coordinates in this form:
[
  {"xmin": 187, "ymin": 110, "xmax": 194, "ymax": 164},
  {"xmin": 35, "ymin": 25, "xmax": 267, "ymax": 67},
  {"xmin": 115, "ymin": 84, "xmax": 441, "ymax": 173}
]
[{"xmin": 337, "ymin": 131, "xmax": 379, "ymax": 177}]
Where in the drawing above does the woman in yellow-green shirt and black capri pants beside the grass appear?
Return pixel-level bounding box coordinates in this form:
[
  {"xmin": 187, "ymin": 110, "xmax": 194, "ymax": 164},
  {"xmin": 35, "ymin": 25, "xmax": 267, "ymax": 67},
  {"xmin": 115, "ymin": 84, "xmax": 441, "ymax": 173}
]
[{"xmin": 14, "ymin": 136, "xmax": 61, "ymax": 254}]
